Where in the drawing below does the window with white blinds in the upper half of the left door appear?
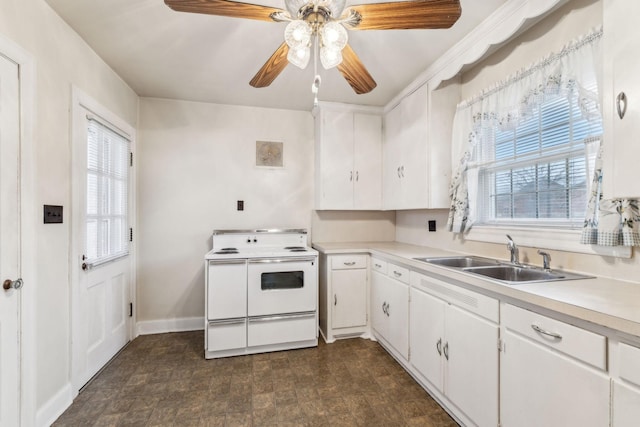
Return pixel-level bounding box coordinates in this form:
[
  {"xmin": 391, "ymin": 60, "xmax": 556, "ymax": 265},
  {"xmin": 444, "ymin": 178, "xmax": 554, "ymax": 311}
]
[{"xmin": 86, "ymin": 118, "xmax": 129, "ymax": 264}]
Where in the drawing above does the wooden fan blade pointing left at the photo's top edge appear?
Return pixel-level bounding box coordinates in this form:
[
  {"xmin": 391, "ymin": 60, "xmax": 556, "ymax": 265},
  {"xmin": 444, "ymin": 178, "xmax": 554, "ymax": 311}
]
[{"xmin": 164, "ymin": 0, "xmax": 284, "ymax": 22}]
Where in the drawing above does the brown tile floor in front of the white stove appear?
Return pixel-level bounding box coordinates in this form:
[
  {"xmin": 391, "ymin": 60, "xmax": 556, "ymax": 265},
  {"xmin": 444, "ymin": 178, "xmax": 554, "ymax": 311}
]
[{"xmin": 54, "ymin": 331, "xmax": 457, "ymax": 427}]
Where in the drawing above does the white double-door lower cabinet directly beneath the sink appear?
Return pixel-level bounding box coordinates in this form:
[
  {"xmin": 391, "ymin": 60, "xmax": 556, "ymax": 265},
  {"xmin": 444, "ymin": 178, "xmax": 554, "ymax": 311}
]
[{"xmin": 409, "ymin": 272, "xmax": 499, "ymax": 426}]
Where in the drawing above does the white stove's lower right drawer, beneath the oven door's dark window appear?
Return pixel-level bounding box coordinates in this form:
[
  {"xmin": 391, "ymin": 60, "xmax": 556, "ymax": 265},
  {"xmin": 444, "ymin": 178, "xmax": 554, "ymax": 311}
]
[{"xmin": 247, "ymin": 312, "xmax": 318, "ymax": 347}]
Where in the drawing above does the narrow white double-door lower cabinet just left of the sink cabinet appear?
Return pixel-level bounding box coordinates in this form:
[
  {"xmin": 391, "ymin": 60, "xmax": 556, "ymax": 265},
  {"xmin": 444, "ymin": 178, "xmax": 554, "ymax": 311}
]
[{"xmin": 371, "ymin": 258, "xmax": 409, "ymax": 360}]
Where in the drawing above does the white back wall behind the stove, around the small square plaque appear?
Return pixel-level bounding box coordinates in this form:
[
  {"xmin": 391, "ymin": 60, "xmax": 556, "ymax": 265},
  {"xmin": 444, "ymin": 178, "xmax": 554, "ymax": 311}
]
[{"xmin": 136, "ymin": 98, "xmax": 314, "ymax": 330}]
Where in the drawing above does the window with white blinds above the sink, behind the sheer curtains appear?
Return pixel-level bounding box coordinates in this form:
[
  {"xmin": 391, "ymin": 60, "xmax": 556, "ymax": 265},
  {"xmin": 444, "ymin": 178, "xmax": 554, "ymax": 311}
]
[{"xmin": 477, "ymin": 92, "xmax": 602, "ymax": 228}]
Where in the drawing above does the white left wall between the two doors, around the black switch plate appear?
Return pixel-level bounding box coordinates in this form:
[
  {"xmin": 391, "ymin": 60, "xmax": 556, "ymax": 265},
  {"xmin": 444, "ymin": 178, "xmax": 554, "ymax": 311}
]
[{"xmin": 0, "ymin": 0, "xmax": 138, "ymax": 418}]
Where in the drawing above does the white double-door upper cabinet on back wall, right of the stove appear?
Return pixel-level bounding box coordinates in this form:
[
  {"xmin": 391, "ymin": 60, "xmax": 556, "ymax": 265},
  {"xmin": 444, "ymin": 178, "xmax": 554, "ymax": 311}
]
[{"xmin": 315, "ymin": 107, "xmax": 382, "ymax": 210}]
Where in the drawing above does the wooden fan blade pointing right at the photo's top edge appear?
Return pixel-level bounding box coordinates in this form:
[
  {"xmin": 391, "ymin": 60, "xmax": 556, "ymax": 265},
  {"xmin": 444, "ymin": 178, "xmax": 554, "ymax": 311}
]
[{"xmin": 349, "ymin": 0, "xmax": 462, "ymax": 30}]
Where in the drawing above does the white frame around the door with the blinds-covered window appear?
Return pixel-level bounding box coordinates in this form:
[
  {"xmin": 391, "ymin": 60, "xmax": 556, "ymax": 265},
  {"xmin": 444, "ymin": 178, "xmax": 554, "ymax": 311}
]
[{"xmin": 69, "ymin": 85, "xmax": 137, "ymax": 398}]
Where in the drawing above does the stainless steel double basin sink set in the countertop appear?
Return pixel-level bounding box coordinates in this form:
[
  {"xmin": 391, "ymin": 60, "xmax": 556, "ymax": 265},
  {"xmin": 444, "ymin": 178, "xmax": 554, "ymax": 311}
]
[{"xmin": 414, "ymin": 256, "xmax": 592, "ymax": 285}]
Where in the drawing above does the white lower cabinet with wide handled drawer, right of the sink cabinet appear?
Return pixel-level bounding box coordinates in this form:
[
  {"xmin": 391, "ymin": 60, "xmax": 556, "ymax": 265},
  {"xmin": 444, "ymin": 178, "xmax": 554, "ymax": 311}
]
[{"xmin": 500, "ymin": 304, "xmax": 608, "ymax": 427}]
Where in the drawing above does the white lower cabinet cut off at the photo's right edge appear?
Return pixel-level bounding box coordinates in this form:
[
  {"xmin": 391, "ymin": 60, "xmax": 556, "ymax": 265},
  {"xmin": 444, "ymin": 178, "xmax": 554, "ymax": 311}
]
[{"xmin": 611, "ymin": 343, "xmax": 640, "ymax": 427}]
